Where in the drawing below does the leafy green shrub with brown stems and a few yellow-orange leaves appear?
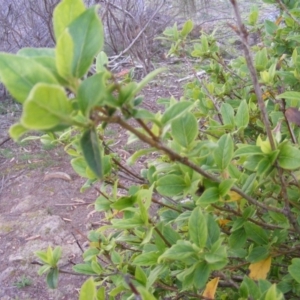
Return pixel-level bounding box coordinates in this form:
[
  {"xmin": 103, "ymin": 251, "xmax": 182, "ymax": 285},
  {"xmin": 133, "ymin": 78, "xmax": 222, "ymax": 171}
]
[{"xmin": 0, "ymin": 0, "xmax": 300, "ymax": 300}]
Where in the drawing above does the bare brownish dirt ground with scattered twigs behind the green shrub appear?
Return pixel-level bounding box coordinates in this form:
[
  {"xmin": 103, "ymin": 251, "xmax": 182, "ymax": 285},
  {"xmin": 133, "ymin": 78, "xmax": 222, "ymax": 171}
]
[{"xmin": 0, "ymin": 62, "xmax": 186, "ymax": 300}]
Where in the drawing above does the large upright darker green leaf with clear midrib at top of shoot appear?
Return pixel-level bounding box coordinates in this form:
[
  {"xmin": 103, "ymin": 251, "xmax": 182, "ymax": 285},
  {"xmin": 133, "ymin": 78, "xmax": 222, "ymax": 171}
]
[{"xmin": 69, "ymin": 7, "xmax": 103, "ymax": 78}]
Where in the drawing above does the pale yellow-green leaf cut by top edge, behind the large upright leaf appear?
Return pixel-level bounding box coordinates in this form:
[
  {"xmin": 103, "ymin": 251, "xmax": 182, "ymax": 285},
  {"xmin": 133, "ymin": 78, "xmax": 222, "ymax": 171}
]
[{"xmin": 53, "ymin": 0, "xmax": 86, "ymax": 40}]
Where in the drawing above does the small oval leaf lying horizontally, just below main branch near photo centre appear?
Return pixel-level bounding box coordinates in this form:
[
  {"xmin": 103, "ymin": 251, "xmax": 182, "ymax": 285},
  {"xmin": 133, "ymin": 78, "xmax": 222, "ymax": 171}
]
[{"xmin": 156, "ymin": 175, "xmax": 187, "ymax": 197}]
